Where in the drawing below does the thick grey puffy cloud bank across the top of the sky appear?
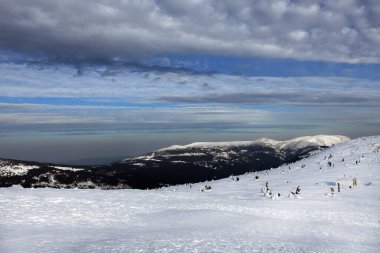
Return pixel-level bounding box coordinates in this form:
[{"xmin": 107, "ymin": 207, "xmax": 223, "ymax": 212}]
[{"xmin": 0, "ymin": 0, "xmax": 380, "ymax": 63}]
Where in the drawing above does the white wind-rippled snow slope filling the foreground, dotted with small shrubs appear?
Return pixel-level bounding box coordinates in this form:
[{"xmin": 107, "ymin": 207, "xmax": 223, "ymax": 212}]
[{"xmin": 0, "ymin": 136, "xmax": 380, "ymax": 252}]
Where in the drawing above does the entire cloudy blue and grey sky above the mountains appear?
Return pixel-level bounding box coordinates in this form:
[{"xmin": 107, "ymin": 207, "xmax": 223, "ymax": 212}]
[{"xmin": 0, "ymin": 0, "xmax": 380, "ymax": 163}]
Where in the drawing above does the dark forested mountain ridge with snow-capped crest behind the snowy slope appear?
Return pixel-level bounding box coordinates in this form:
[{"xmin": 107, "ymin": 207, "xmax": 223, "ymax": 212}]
[{"xmin": 0, "ymin": 135, "xmax": 349, "ymax": 189}]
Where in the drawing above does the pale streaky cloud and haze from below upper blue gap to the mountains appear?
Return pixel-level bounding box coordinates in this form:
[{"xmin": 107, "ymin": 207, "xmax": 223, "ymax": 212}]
[{"xmin": 0, "ymin": 63, "xmax": 380, "ymax": 162}]
